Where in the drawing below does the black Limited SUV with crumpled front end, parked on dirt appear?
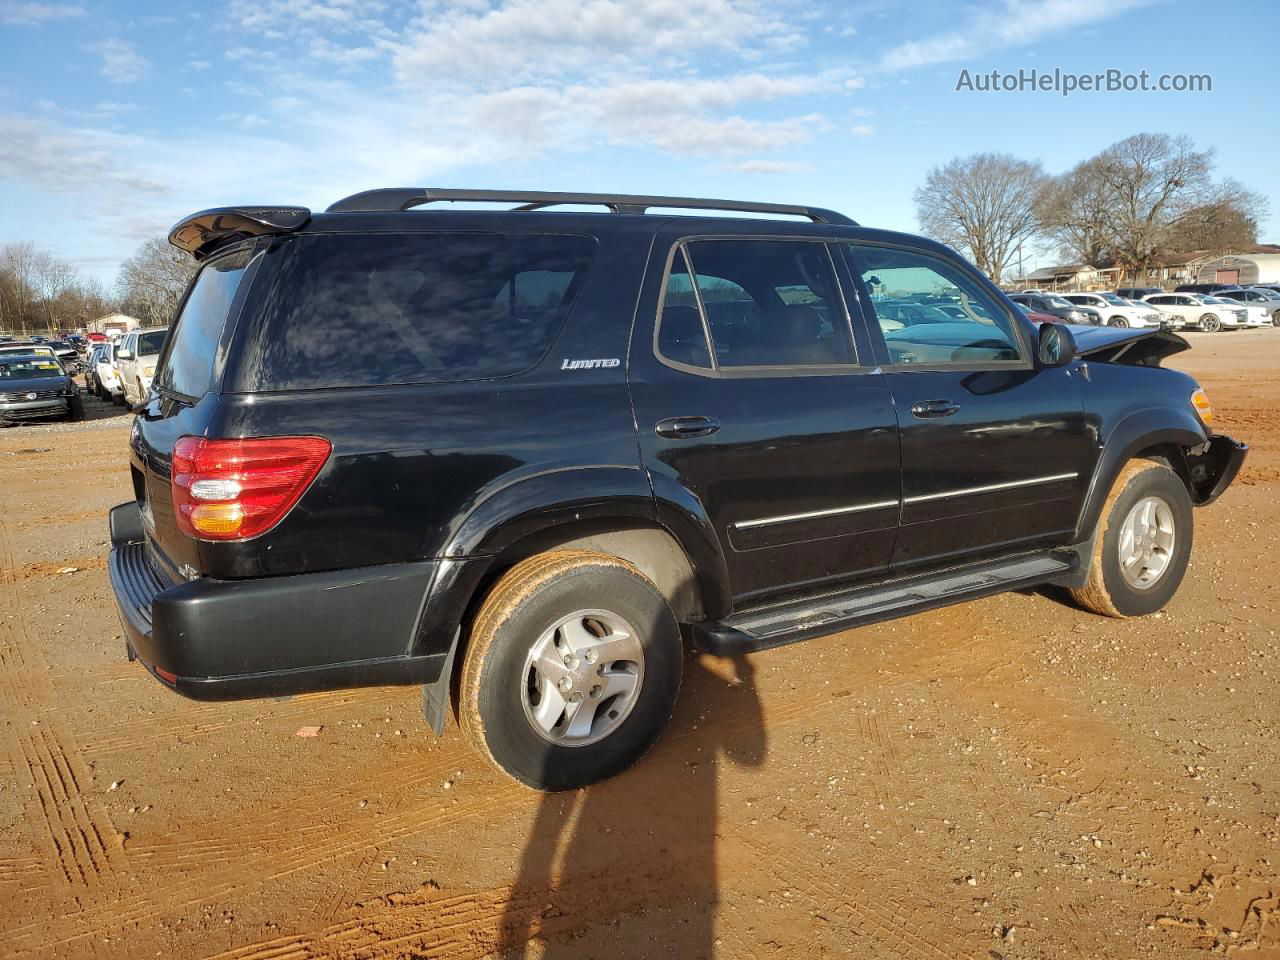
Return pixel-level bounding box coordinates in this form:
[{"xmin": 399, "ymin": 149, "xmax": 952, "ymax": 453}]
[{"xmin": 110, "ymin": 189, "xmax": 1245, "ymax": 790}]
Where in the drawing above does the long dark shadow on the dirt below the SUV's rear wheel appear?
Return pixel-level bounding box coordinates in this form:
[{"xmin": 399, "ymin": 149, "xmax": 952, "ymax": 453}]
[{"xmin": 494, "ymin": 657, "xmax": 765, "ymax": 960}]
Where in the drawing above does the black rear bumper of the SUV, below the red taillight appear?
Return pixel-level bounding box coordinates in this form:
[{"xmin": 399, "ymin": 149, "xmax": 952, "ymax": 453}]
[{"xmin": 108, "ymin": 503, "xmax": 447, "ymax": 700}]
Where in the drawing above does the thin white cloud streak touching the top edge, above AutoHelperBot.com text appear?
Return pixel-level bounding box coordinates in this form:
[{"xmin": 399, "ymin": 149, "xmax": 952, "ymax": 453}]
[{"xmin": 879, "ymin": 0, "xmax": 1151, "ymax": 72}]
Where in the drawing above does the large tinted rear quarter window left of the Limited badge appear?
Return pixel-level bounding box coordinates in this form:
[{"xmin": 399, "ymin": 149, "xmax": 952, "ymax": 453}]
[{"xmin": 244, "ymin": 233, "xmax": 595, "ymax": 390}]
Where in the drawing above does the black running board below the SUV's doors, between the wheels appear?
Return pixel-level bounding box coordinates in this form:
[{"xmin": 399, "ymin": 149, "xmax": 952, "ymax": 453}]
[{"xmin": 689, "ymin": 552, "xmax": 1078, "ymax": 657}]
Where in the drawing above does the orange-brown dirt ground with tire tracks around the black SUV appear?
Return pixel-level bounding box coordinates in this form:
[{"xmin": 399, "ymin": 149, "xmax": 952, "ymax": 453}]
[{"xmin": 0, "ymin": 330, "xmax": 1280, "ymax": 960}]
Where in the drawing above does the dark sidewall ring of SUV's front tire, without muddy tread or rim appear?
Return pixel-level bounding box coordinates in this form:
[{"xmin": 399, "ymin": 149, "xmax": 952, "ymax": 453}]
[{"xmin": 1101, "ymin": 467, "xmax": 1194, "ymax": 617}]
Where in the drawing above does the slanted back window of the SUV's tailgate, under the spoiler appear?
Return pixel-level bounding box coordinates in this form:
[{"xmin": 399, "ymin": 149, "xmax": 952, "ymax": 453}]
[{"xmin": 157, "ymin": 250, "xmax": 251, "ymax": 397}]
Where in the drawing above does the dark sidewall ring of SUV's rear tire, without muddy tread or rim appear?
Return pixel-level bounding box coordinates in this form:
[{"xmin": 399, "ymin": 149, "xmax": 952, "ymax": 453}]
[{"xmin": 475, "ymin": 564, "xmax": 684, "ymax": 790}]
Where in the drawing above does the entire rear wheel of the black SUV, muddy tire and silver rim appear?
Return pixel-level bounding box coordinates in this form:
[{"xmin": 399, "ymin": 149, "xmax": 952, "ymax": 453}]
[{"xmin": 458, "ymin": 550, "xmax": 682, "ymax": 790}]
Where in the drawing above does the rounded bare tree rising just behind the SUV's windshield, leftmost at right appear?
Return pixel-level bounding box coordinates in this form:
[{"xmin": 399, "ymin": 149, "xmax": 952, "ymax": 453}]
[{"xmin": 915, "ymin": 154, "xmax": 1048, "ymax": 283}]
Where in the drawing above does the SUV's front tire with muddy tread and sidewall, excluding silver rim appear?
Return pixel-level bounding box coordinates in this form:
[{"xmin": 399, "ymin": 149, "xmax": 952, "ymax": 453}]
[{"xmin": 1071, "ymin": 460, "xmax": 1193, "ymax": 617}]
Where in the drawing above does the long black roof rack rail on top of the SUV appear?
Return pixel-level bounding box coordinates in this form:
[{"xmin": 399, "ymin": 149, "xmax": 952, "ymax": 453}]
[{"xmin": 326, "ymin": 187, "xmax": 858, "ymax": 227}]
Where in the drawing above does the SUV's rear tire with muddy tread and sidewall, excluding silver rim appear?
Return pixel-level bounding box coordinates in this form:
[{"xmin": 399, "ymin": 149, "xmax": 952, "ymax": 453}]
[{"xmin": 458, "ymin": 550, "xmax": 684, "ymax": 790}]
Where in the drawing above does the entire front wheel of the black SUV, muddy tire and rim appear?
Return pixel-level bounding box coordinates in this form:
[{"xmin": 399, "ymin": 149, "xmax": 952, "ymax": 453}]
[{"xmin": 1071, "ymin": 460, "xmax": 1193, "ymax": 617}]
